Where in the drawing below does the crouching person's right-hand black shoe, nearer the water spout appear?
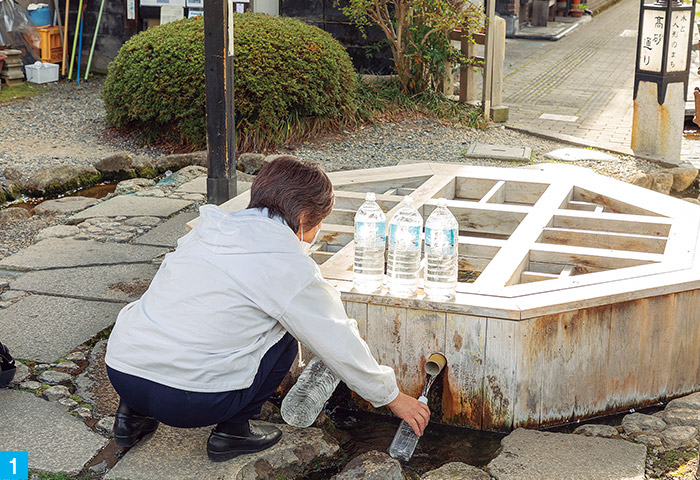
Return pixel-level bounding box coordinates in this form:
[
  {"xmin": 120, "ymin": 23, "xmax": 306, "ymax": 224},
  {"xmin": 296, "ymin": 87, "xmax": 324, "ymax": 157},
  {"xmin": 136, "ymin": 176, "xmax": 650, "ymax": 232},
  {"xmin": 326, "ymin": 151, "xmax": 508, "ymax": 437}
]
[{"xmin": 207, "ymin": 425, "xmax": 282, "ymax": 462}]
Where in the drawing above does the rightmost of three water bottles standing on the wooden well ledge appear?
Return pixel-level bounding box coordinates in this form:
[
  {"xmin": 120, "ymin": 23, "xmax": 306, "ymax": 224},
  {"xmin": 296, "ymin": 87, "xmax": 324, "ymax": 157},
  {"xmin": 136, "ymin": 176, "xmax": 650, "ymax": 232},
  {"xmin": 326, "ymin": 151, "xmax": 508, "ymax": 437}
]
[{"xmin": 425, "ymin": 198, "xmax": 459, "ymax": 301}]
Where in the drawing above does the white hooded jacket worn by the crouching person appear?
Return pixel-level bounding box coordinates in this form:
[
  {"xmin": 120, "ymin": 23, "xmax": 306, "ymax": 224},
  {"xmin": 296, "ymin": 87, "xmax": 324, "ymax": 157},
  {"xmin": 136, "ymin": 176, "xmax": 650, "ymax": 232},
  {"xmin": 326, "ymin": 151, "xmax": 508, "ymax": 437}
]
[{"xmin": 105, "ymin": 205, "xmax": 399, "ymax": 407}]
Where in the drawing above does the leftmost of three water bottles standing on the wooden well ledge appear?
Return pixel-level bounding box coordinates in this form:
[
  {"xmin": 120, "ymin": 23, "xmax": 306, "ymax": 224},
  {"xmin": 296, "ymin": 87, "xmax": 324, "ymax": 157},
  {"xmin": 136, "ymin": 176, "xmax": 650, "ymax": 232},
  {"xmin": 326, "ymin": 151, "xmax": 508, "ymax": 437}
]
[{"xmin": 352, "ymin": 192, "xmax": 386, "ymax": 293}]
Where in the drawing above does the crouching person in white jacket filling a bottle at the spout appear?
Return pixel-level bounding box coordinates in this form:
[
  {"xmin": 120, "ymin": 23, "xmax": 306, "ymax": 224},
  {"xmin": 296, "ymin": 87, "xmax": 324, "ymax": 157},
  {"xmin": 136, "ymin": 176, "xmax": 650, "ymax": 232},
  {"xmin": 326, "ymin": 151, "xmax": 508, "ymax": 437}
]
[{"xmin": 106, "ymin": 156, "xmax": 430, "ymax": 461}]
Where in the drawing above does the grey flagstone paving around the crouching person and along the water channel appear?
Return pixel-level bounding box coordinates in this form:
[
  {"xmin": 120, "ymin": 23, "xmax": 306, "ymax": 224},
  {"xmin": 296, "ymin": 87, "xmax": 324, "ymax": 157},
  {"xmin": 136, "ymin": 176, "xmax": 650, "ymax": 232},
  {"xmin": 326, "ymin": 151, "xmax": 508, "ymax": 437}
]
[{"xmin": 0, "ymin": 169, "xmax": 700, "ymax": 480}]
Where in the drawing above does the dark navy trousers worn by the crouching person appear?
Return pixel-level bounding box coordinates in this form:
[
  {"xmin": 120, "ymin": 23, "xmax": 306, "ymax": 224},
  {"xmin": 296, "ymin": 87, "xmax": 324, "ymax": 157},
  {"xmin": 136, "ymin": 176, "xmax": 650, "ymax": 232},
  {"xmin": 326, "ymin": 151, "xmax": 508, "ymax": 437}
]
[{"xmin": 107, "ymin": 333, "xmax": 298, "ymax": 428}]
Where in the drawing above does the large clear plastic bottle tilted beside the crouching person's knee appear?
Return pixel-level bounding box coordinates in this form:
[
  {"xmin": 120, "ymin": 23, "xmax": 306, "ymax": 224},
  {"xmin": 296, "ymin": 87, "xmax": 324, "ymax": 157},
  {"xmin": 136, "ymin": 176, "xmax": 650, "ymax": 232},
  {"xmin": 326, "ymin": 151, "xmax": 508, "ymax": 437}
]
[{"xmin": 280, "ymin": 357, "xmax": 340, "ymax": 427}]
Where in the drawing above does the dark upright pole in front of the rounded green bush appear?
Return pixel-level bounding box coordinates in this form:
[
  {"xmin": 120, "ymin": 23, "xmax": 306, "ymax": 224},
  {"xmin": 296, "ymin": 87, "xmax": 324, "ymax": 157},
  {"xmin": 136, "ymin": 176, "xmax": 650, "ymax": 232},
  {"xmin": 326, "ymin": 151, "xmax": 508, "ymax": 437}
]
[{"xmin": 204, "ymin": 0, "xmax": 236, "ymax": 205}]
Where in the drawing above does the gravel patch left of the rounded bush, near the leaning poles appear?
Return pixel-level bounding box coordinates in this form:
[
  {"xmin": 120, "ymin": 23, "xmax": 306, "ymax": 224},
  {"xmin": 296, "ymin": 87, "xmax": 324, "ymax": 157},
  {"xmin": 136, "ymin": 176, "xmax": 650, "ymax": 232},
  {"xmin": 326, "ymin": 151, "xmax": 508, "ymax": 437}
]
[{"xmin": 0, "ymin": 76, "xmax": 162, "ymax": 185}]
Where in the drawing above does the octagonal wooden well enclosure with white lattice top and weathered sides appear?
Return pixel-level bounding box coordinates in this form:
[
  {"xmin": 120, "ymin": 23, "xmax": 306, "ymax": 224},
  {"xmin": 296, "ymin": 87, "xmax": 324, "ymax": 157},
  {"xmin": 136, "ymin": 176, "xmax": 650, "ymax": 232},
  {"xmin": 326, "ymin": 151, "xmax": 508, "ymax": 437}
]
[{"xmin": 187, "ymin": 164, "xmax": 700, "ymax": 431}]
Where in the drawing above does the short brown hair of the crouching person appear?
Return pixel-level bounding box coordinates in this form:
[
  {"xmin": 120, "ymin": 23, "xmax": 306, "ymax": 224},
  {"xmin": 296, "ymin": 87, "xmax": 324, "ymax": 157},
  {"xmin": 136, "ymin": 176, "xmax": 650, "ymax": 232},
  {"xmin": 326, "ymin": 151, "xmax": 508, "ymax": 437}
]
[{"xmin": 248, "ymin": 155, "xmax": 335, "ymax": 233}]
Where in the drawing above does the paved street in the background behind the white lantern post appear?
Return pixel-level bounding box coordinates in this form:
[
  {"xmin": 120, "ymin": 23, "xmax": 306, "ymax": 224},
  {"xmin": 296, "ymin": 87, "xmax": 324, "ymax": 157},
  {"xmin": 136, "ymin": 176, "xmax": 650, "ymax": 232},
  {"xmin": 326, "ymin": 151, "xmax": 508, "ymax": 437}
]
[{"xmin": 503, "ymin": 0, "xmax": 700, "ymax": 164}]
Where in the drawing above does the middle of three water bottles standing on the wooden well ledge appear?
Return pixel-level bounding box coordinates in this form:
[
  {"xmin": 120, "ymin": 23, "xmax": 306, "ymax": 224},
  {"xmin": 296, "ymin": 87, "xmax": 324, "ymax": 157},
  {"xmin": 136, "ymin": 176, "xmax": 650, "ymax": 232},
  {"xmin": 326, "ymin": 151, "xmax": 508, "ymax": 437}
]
[{"xmin": 387, "ymin": 197, "xmax": 423, "ymax": 297}]
